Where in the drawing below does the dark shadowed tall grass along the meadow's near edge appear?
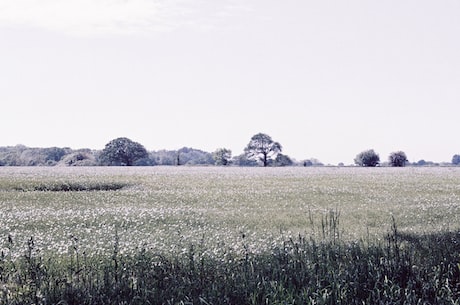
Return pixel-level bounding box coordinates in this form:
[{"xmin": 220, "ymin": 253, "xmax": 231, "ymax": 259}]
[{"xmin": 0, "ymin": 222, "xmax": 460, "ymax": 305}]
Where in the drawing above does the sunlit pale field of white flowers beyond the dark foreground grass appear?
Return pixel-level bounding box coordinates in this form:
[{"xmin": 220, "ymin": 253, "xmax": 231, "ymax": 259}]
[{"xmin": 0, "ymin": 167, "xmax": 460, "ymax": 252}]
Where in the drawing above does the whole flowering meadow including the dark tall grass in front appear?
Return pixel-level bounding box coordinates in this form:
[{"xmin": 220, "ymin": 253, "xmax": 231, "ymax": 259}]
[{"xmin": 0, "ymin": 167, "xmax": 460, "ymax": 304}]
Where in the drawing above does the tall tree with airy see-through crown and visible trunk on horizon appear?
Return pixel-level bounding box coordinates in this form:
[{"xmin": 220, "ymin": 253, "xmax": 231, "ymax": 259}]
[{"xmin": 244, "ymin": 133, "xmax": 282, "ymax": 166}]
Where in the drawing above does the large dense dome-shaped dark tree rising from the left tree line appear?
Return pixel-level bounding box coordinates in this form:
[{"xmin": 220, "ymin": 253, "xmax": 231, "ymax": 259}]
[{"xmin": 99, "ymin": 138, "xmax": 149, "ymax": 166}]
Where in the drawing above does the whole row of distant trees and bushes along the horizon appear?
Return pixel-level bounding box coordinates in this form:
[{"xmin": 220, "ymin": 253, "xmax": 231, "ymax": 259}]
[{"xmin": 0, "ymin": 133, "xmax": 460, "ymax": 167}]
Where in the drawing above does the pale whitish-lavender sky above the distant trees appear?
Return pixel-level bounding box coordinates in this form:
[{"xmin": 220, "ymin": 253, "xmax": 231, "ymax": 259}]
[{"xmin": 0, "ymin": 0, "xmax": 460, "ymax": 164}]
